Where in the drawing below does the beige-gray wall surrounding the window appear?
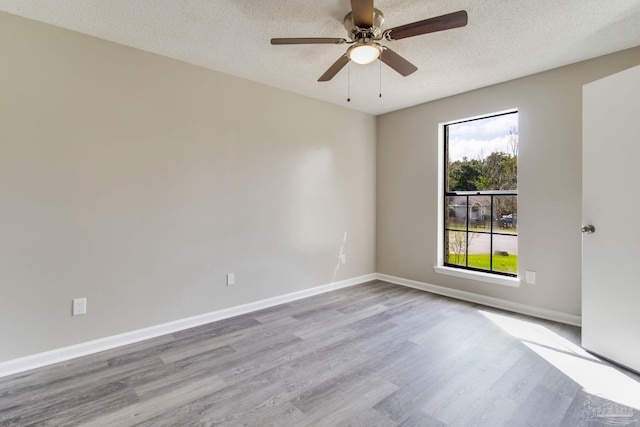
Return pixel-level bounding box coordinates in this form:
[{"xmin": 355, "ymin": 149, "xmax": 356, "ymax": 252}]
[{"xmin": 376, "ymin": 47, "xmax": 640, "ymax": 315}]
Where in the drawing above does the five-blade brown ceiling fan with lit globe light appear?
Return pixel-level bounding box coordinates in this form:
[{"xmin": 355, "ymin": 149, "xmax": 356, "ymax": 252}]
[{"xmin": 271, "ymin": 0, "xmax": 467, "ymax": 82}]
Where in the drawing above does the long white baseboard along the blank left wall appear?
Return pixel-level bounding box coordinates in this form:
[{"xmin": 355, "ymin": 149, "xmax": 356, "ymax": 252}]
[{"xmin": 0, "ymin": 273, "xmax": 377, "ymax": 377}]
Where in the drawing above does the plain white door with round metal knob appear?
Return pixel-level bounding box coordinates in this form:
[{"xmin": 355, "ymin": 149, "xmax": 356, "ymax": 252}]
[{"xmin": 584, "ymin": 66, "xmax": 640, "ymax": 371}]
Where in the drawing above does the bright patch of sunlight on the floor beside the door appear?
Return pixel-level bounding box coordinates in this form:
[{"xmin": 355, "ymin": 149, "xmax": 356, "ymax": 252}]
[{"xmin": 480, "ymin": 310, "xmax": 640, "ymax": 409}]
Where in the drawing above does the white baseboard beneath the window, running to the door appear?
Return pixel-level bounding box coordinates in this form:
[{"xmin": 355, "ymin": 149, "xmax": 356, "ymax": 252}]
[{"xmin": 377, "ymin": 273, "xmax": 582, "ymax": 326}]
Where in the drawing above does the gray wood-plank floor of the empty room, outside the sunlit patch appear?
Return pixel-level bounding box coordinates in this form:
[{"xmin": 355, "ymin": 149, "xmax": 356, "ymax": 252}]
[{"xmin": 0, "ymin": 282, "xmax": 640, "ymax": 427}]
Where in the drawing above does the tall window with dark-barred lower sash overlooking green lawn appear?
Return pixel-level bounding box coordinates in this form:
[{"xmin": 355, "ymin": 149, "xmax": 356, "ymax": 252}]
[{"xmin": 440, "ymin": 111, "xmax": 518, "ymax": 276}]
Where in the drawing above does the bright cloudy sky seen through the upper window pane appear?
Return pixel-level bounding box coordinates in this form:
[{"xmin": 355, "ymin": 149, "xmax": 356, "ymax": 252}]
[{"xmin": 449, "ymin": 113, "xmax": 518, "ymax": 162}]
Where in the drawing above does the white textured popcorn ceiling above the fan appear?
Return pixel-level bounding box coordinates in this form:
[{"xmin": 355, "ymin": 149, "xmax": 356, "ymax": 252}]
[{"xmin": 0, "ymin": 0, "xmax": 640, "ymax": 115}]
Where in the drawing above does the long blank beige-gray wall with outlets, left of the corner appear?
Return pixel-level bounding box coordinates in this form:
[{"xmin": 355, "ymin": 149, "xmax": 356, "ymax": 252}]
[{"xmin": 0, "ymin": 13, "xmax": 376, "ymax": 361}]
